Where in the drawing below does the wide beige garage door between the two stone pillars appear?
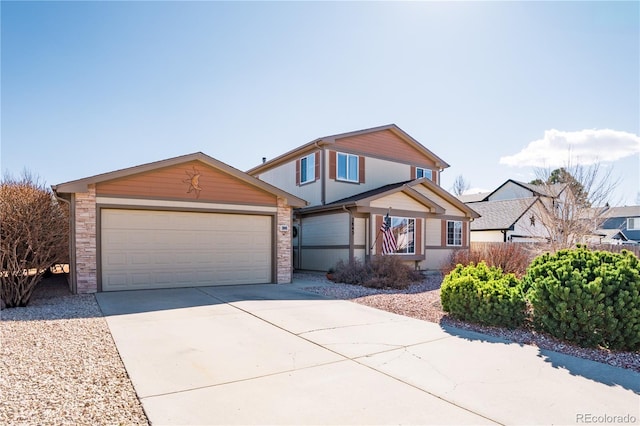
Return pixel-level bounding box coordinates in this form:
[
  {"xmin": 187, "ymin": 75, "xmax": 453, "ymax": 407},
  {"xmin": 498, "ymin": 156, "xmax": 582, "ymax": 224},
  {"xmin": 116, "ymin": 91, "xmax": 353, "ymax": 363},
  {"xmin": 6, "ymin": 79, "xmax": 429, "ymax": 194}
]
[{"xmin": 101, "ymin": 209, "xmax": 272, "ymax": 291}]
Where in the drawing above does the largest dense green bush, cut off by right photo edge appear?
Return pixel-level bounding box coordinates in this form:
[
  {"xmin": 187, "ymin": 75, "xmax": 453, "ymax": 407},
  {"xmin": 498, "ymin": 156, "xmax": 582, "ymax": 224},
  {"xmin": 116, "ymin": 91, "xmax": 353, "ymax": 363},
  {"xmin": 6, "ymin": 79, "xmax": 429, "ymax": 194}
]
[{"xmin": 523, "ymin": 247, "xmax": 640, "ymax": 350}]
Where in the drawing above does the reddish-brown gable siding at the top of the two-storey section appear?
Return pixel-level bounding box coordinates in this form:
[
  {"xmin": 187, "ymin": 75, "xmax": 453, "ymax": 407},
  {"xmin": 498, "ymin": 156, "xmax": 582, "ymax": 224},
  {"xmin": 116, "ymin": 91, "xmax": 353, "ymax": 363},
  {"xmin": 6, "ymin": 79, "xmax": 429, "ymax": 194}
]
[{"xmin": 334, "ymin": 130, "xmax": 436, "ymax": 168}]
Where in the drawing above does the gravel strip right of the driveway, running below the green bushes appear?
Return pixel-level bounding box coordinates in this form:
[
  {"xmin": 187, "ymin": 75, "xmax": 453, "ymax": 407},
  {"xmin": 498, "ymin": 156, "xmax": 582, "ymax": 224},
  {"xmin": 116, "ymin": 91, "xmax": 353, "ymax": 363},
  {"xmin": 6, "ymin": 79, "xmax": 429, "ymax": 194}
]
[{"xmin": 295, "ymin": 273, "xmax": 640, "ymax": 372}]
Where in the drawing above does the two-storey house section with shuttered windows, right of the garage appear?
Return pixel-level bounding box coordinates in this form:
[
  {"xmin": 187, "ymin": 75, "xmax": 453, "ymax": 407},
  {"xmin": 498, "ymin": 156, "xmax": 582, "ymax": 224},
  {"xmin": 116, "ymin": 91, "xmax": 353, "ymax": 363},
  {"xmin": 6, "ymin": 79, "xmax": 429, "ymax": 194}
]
[{"xmin": 248, "ymin": 124, "xmax": 478, "ymax": 270}]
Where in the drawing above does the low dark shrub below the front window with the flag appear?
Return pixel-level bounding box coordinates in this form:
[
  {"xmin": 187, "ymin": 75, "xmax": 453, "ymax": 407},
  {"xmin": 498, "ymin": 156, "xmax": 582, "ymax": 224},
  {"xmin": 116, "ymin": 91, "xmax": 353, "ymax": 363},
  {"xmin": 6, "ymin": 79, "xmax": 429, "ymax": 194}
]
[{"xmin": 333, "ymin": 256, "xmax": 422, "ymax": 289}]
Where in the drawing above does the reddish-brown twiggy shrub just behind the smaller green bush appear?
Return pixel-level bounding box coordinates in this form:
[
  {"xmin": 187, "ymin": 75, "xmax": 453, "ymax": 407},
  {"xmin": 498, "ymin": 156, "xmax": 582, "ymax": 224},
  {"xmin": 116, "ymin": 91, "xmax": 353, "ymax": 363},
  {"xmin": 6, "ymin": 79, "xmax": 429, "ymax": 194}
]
[{"xmin": 443, "ymin": 243, "xmax": 533, "ymax": 277}]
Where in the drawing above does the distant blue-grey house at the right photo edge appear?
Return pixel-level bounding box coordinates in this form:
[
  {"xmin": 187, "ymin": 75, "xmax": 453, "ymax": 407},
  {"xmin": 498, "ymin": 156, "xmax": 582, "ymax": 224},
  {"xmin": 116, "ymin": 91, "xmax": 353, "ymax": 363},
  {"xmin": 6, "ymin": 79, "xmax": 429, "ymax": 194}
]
[{"xmin": 596, "ymin": 206, "xmax": 640, "ymax": 244}]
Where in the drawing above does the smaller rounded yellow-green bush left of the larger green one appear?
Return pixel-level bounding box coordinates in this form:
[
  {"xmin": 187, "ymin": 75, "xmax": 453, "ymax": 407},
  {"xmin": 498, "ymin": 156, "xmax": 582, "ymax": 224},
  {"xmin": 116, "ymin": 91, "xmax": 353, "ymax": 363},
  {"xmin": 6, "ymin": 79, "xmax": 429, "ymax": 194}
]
[{"xmin": 440, "ymin": 262, "xmax": 526, "ymax": 328}]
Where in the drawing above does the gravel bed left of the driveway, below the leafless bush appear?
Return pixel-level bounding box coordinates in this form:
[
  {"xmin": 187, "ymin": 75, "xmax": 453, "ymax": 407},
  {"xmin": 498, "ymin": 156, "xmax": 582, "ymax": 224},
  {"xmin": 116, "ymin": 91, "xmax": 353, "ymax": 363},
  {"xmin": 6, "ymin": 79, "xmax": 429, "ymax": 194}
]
[{"xmin": 0, "ymin": 276, "xmax": 148, "ymax": 425}]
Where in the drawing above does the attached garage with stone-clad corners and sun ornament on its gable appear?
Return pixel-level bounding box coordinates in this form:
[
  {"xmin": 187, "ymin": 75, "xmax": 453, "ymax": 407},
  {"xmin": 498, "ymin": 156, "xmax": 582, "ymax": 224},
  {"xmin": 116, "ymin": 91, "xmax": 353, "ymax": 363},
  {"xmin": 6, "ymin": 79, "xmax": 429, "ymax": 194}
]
[{"xmin": 53, "ymin": 153, "xmax": 306, "ymax": 293}]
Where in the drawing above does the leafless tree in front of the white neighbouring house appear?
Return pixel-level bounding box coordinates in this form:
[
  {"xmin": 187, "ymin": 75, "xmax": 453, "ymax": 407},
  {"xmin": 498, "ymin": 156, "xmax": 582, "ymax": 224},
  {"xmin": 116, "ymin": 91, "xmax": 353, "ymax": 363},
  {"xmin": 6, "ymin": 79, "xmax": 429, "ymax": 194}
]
[{"xmin": 531, "ymin": 163, "xmax": 620, "ymax": 249}]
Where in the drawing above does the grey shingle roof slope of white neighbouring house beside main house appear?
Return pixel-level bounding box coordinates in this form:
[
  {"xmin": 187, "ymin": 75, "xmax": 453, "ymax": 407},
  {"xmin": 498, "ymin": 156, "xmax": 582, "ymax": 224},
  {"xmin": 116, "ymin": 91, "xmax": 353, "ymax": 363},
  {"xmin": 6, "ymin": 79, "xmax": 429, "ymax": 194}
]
[{"xmin": 467, "ymin": 197, "xmax": 538, "ymax": 231}]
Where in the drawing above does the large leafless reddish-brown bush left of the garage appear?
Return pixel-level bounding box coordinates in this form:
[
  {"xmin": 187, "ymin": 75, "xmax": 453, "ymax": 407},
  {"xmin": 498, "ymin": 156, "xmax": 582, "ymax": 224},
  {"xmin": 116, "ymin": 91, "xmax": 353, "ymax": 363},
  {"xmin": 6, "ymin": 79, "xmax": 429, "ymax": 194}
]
[{"xmin": 0, "ymin": 171, "xmax": 69, "ymax": 308}]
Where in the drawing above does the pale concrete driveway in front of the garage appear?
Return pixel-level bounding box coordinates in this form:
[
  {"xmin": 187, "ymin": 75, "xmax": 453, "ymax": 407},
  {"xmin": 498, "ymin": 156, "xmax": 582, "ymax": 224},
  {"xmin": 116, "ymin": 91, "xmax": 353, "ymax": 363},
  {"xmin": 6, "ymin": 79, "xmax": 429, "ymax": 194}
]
[{"xmin": 96, "ymin": 283, "xmax": 640, "ymax": 425}]
